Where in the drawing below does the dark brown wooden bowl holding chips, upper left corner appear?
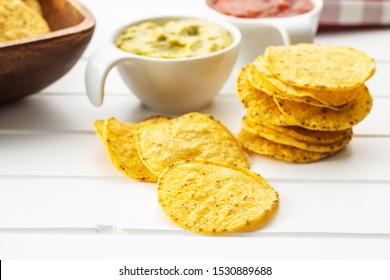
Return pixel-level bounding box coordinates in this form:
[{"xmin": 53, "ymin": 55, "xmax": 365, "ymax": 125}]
[{"xmin": 0, "ymin": 0, "xmax": 95, "ymax": 102}]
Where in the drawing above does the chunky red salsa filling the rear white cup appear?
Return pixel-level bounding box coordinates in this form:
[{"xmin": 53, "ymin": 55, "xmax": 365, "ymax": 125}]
[{"xmin": 208, "ymin": 0, "xmax": 314, "ymax": 18}]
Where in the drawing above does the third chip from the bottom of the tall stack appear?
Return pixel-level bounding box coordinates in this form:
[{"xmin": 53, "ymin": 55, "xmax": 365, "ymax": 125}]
[{"xmin": 243, "ymin": 115, "xmax": 353, "ymax": 144}]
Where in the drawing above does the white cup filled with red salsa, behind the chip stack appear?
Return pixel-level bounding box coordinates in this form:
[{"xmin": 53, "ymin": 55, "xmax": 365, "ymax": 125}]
[{"xmin": 202, "ymin": 0, "xmax": 323, "ymax": 68}]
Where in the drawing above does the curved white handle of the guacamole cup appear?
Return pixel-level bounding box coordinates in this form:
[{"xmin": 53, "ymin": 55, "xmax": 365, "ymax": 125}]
[{"xmin": 85, "ymin": 44, "xmax": 134, "ymax": 106}]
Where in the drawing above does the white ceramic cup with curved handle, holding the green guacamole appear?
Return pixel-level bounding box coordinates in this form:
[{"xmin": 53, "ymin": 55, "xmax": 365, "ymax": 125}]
[{"xmin": 86, "ymin": 16, "xmax": 241, "ymax": 114}]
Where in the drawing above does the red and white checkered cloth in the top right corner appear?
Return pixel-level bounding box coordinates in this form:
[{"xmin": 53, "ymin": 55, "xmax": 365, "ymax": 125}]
[{"xmin": 320, "ymin": 0, "xmax": 390, "ymax": 27}]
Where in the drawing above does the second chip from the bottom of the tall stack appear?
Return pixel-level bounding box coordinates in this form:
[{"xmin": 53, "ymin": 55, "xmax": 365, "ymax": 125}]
[{"xmin": 242, "ymin": 118, "xmax": 352, "ymax": 153}]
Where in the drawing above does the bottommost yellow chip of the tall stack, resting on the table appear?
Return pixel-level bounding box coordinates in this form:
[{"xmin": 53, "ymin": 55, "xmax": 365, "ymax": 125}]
[{"xmin": 238, "ymin": 130, "xmax": 331, "ymax": 163}]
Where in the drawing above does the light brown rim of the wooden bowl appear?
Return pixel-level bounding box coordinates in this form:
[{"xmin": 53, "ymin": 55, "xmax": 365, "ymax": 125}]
[{"xmin": 0, "ymin": 0, "xmax": 96, "ymax": 49}]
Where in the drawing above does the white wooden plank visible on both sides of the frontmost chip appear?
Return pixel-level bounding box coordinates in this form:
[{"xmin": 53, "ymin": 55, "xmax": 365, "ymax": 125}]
[{"xmin": 0, "ymin": 177, "xmax": 390, "ymax": 236}]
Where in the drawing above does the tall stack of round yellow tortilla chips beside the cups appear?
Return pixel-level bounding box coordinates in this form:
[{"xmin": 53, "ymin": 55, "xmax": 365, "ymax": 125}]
[{"xmin": 237, "ymin": 44, "xmax": 376, "ymax": 163}]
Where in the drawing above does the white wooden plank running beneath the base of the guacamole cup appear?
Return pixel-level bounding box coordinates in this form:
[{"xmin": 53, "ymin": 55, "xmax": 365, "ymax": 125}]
[{"xmin": 0, "ymin": 94, "xmax": 390, "ymax": 136}]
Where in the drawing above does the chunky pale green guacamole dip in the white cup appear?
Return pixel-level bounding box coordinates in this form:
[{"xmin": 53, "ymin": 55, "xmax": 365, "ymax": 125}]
[{"xmin": 116, "ymin": 19, "xmax": 233, "ymax": 58}]
